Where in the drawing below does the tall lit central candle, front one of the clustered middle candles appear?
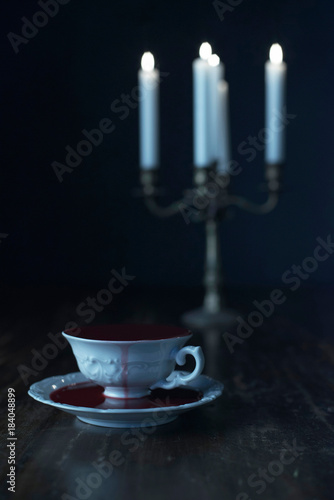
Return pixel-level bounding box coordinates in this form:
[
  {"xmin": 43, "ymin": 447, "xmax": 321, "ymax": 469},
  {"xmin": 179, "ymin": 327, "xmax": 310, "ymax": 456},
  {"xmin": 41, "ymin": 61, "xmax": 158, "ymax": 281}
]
[{"xmin": 193, "ymin": 42, "xmax": 212, "ymax": 168}]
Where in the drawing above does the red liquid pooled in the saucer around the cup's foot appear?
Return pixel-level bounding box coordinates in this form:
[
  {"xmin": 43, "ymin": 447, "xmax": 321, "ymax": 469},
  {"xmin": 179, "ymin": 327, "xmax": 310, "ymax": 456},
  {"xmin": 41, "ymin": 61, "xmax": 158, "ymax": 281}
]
[{"xmin": 50, "ymin": 381, "xmax": 203, "ymax": 410}]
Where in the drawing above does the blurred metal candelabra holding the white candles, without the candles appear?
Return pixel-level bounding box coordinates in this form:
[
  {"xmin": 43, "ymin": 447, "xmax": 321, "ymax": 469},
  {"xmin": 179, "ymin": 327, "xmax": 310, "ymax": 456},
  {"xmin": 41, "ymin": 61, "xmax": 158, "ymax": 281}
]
[{"xmin": 140, "ymin": 163, "xmax": 282, "ymax": 329}]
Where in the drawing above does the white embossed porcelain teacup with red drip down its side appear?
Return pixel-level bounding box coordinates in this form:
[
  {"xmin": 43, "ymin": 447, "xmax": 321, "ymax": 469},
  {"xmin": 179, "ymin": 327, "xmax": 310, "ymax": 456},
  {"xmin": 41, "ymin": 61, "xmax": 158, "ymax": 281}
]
[{"xmin": 63, "ymin": 324, "xmax": 204, "ymax": 399}]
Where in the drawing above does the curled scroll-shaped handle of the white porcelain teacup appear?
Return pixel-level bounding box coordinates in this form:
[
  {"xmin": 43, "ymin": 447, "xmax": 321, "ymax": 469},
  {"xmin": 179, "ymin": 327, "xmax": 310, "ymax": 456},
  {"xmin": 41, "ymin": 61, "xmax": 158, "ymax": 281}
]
[{"xmin": 151, "ymin": 345, "xmax": 204, "ymax": 389}]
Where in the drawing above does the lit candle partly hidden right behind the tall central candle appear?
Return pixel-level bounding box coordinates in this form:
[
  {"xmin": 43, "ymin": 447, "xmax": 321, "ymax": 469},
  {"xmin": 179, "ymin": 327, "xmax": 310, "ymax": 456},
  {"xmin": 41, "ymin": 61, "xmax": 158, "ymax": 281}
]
[{"xmin": 208, "ymin": 54, "xmax": 225, "ymax": 162}]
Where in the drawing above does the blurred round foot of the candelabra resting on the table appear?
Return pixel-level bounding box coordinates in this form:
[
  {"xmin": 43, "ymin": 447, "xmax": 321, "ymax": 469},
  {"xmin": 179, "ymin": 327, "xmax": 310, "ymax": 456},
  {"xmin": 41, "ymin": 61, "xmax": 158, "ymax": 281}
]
[{"xmin": 181, "ymin": 307, "xmax": 240, "ymax": 330}]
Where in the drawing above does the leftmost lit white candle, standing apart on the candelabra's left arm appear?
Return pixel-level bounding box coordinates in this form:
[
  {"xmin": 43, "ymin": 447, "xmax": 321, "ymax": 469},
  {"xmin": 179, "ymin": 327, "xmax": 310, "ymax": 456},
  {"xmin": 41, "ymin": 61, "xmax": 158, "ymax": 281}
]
[{"xmin": 138, "ymin": 52, "xmax": 160, "ymax": 170}]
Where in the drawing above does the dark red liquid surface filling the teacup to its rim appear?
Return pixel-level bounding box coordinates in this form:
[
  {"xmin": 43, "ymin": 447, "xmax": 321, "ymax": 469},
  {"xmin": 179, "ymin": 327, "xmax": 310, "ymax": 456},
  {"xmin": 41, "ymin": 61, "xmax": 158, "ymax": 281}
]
[{"xmin": 64, "ymin": 324, "xmax": 191, "ymax": 342}]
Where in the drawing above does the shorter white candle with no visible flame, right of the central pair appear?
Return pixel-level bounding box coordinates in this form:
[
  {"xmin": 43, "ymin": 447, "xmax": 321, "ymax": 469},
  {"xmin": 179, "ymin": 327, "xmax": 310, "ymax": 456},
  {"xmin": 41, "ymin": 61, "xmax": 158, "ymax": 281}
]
[{"xmin": 215, "ymin": 80, "xmax": 231, "ymax": 174}]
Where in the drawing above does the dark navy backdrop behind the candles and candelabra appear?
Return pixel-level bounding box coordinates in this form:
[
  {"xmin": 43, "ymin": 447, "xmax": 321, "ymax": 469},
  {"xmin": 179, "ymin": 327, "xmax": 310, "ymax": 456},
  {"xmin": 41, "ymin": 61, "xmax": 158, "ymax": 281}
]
[{"xmin": 0, "ymin": 0, "xmax": 334, "ymax": 286}]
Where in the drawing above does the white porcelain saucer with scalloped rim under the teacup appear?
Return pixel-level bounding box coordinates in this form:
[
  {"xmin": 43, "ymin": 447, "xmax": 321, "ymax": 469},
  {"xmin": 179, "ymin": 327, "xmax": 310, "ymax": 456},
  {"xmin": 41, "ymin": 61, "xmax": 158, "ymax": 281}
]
[{"xmin": 28, "ymin": 372, "xmax": 224, "ymax": 427}]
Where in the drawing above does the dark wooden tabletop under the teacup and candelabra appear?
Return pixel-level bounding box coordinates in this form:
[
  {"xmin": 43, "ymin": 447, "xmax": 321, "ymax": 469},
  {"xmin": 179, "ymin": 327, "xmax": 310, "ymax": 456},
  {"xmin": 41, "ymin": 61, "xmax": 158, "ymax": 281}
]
[{"xmin": 0, "ymin": 287, "xmax": 334, "ymax": 500}]
